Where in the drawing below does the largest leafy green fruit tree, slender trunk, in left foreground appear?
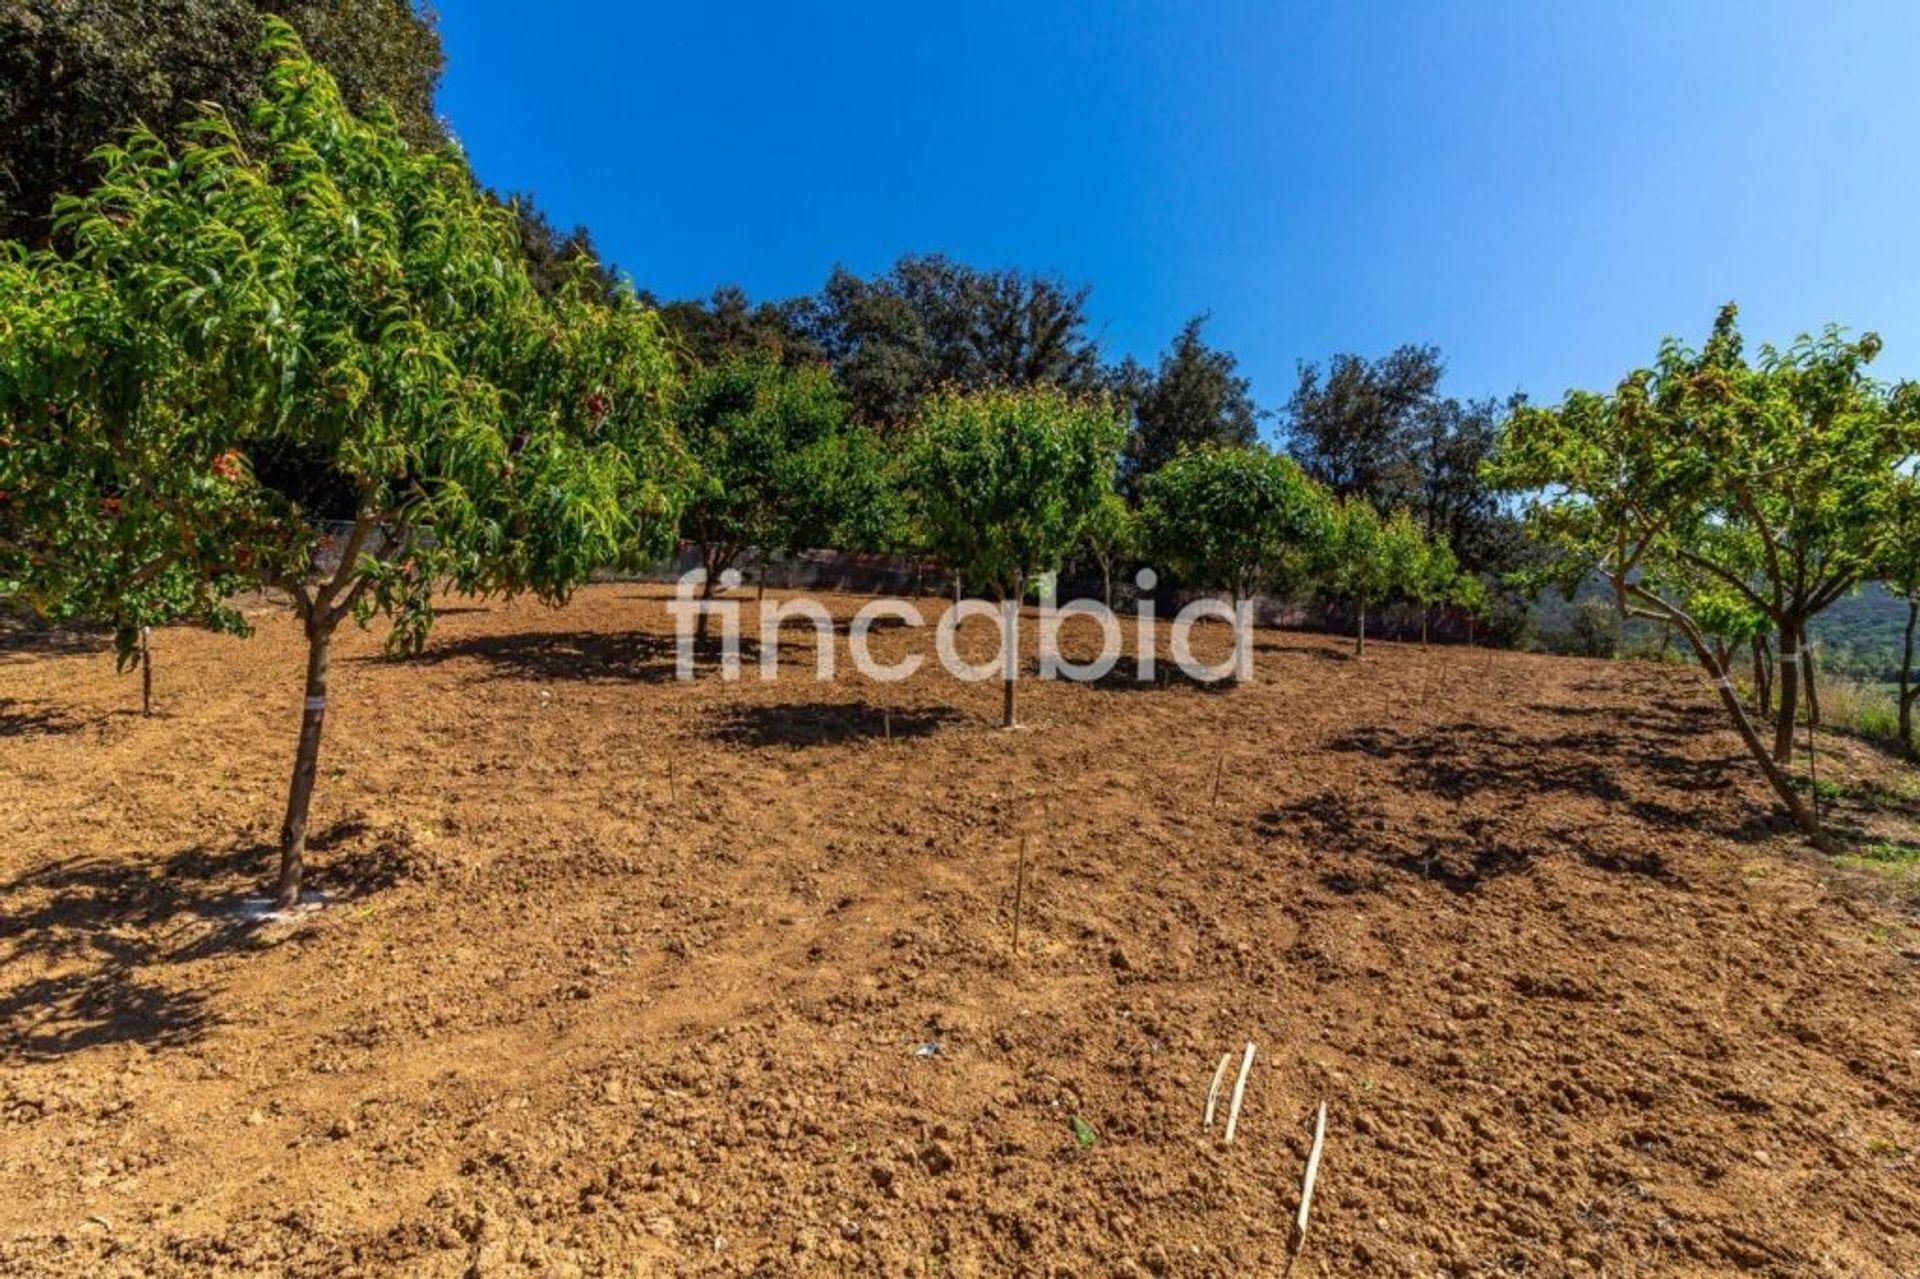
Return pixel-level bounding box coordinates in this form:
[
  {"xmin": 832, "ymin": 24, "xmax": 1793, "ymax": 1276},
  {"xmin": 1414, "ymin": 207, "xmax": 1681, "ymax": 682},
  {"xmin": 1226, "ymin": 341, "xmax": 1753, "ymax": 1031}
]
[{"xmin": 0, "ymin": 23, "xmax": 676, "ymax": 908}]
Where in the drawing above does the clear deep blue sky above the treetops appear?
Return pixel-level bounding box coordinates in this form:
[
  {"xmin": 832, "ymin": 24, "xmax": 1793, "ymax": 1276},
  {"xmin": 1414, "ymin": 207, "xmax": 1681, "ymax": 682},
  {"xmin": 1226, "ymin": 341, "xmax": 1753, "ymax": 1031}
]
[{"xmin": 440, "ymin": 0, "xmax": 1920, "ymax": 422}]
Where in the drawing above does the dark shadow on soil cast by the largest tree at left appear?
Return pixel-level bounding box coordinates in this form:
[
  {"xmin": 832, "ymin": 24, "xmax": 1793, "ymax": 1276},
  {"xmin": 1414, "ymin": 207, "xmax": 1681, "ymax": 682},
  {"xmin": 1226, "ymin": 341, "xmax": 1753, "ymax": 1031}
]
[{"xmin": 0, "ymin": 824, "xmax": 395, "ymax": 1060}]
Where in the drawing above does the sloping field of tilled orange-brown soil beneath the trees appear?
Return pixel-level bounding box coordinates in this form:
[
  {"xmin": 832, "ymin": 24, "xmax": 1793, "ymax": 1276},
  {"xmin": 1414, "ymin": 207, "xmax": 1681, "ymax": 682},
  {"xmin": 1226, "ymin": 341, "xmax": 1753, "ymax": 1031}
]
[{"xmin": 0, "ymin": 584, "xmax": 1920, "ymax": 1275}]
